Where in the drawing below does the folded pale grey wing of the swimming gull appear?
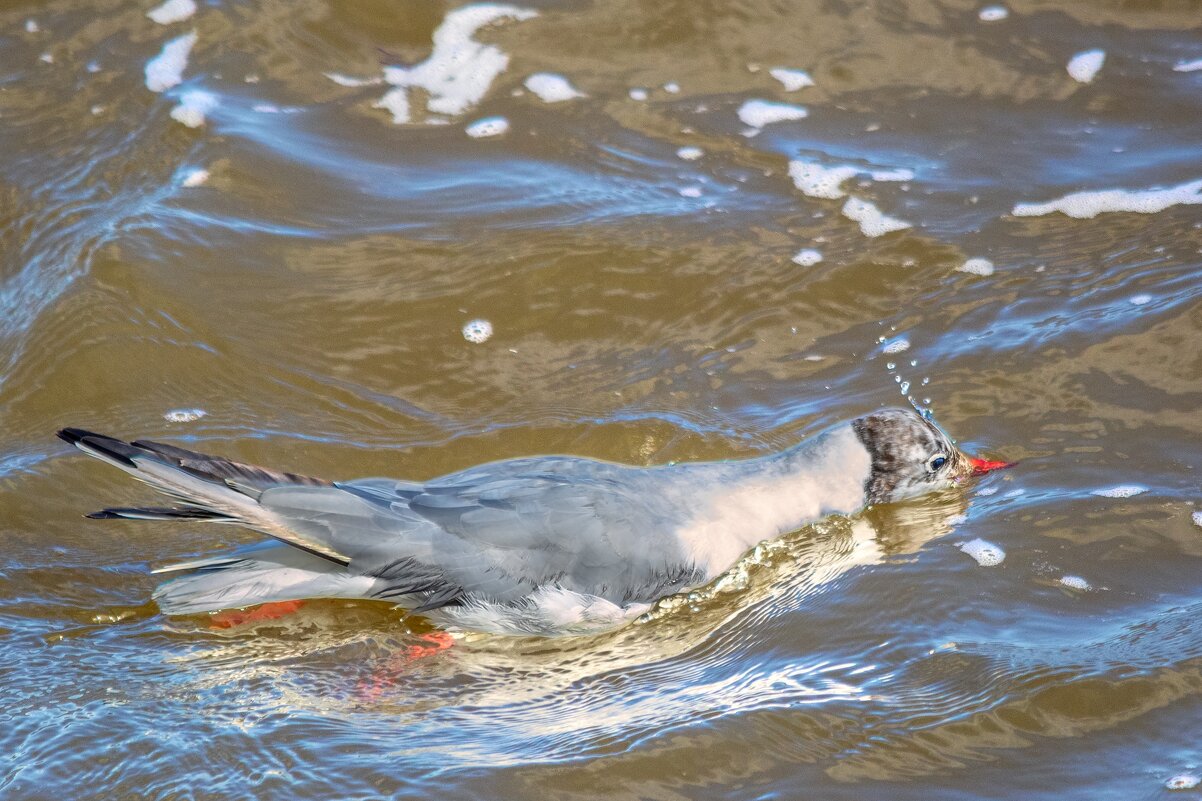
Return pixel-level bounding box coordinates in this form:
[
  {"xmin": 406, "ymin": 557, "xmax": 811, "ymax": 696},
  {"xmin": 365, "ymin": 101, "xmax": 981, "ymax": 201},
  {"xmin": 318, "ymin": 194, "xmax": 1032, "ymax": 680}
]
[{"xmin": 289, "ymin": 457, "xmax": 704, "ymax": 609}]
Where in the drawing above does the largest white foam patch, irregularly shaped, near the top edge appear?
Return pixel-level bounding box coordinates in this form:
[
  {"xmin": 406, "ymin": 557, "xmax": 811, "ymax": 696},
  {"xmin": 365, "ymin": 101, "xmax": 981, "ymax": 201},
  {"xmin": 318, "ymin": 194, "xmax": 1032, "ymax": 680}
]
[{"xmin": 375, "ymin": 4, "xmax": 538, "ymax": 125}]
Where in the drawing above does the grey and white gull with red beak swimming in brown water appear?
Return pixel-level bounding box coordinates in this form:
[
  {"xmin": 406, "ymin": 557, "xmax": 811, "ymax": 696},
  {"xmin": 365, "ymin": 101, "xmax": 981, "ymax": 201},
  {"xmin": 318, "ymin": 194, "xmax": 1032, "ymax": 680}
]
[{"xmin": 58, "ymin": 409, "xmax": 1010, "ymax": 636}]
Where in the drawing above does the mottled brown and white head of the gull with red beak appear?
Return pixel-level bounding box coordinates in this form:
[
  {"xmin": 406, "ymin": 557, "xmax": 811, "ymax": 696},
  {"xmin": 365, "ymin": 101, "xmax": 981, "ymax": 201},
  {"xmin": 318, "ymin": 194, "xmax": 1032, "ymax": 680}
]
[{"xmin": 851, "ymin": 409, "xmax": 1012, "ymax": 504}]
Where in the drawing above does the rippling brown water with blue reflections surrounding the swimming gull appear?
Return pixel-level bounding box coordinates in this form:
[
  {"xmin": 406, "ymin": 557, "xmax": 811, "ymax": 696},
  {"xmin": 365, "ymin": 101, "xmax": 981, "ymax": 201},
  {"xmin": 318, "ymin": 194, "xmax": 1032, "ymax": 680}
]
[{"xmin": 7, "ymin": 0, "xmax": 1202, "ymax": 801}]
